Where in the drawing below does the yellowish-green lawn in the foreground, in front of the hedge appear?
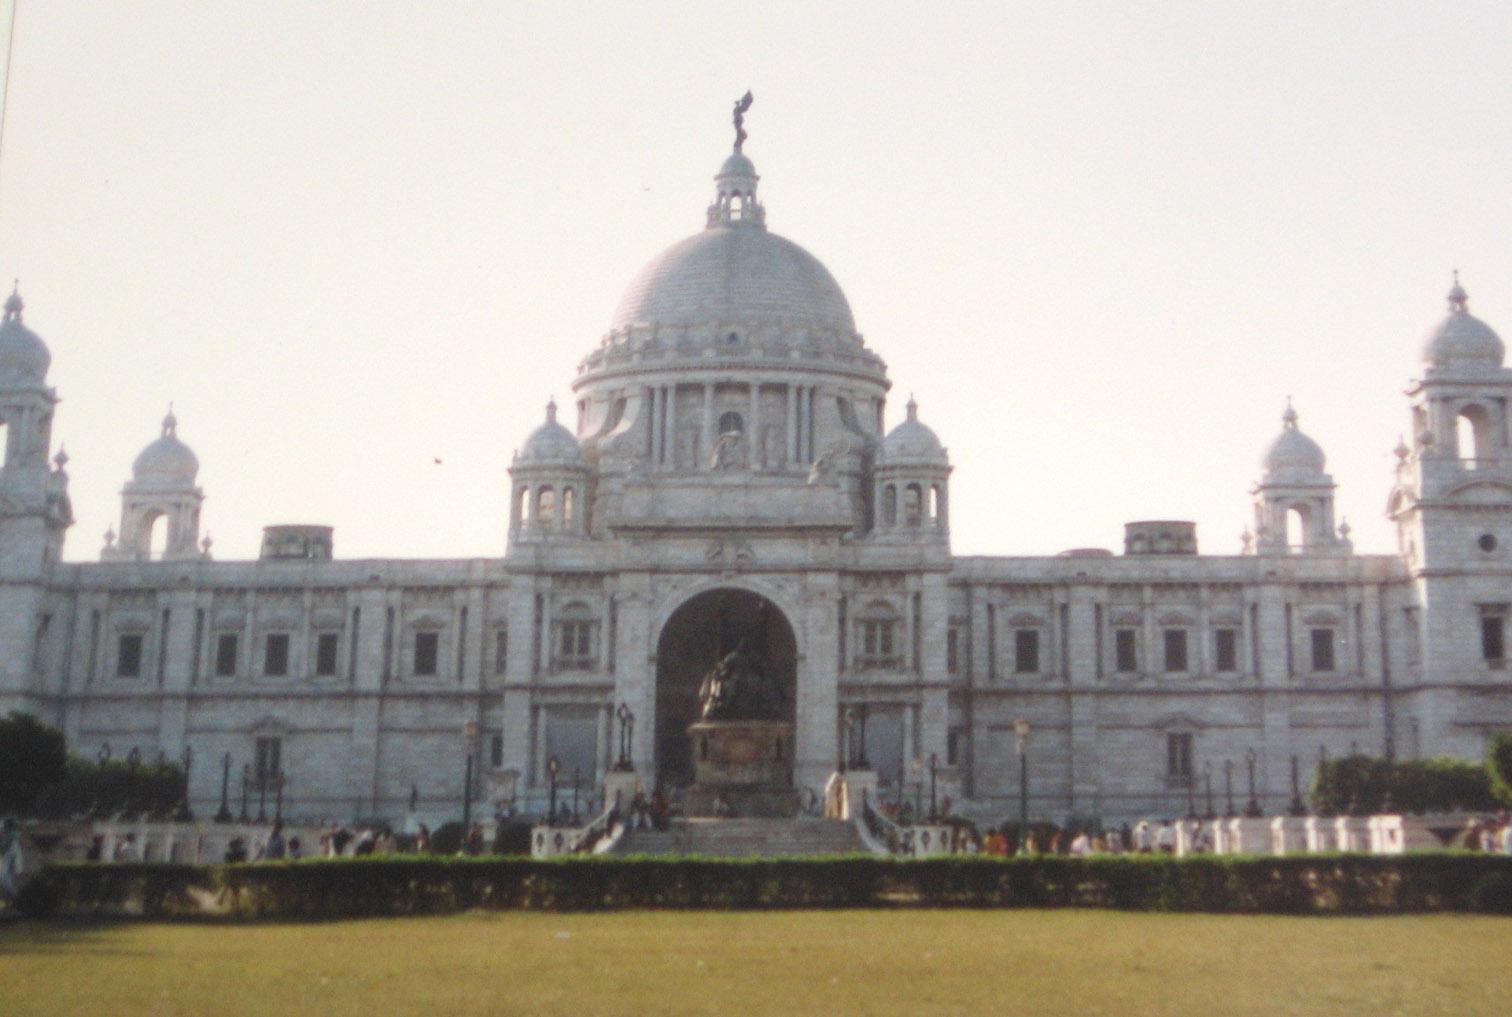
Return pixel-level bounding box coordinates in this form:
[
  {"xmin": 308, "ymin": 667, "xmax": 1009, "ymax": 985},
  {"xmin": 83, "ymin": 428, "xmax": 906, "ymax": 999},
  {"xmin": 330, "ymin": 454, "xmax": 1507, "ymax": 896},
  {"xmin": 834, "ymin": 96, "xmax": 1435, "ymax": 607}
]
[{"xmin": 0, "ymin": 911, "xmax": 1512, "ymax": 1017}]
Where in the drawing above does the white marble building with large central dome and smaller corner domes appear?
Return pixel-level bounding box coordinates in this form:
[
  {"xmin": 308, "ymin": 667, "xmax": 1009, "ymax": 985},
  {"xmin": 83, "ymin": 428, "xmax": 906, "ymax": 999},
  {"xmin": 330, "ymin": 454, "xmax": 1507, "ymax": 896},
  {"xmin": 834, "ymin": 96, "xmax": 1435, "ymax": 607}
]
[{"xmin": 0, "ymin": 130, "xmax": 1512, "ymax": 819}]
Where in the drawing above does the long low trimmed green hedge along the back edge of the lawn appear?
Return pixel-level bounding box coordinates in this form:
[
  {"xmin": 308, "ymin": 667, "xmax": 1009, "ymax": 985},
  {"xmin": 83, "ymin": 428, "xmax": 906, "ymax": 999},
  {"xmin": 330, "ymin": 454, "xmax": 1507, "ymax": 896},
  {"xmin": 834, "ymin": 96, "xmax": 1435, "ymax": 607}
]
[{"xmin": 18, "ymin": 852, "xmax": 1512, "ymax": 919}]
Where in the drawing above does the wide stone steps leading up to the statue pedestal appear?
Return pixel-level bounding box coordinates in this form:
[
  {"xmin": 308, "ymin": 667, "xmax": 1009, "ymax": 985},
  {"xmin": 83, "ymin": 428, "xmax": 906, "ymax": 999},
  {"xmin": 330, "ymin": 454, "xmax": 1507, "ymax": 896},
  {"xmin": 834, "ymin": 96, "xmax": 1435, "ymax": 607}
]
[{"xmin": 617, "ymin": 819, "xmax": 866, "ymax": 858}]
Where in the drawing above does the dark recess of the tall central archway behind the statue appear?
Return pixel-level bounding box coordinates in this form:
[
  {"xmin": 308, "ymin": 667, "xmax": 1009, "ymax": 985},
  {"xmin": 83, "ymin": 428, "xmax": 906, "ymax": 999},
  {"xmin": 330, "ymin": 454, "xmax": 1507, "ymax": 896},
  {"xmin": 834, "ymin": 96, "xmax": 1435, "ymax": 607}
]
[{"xmin": 656, "ymin": 589, "xmax": 798, "ymax": 786}]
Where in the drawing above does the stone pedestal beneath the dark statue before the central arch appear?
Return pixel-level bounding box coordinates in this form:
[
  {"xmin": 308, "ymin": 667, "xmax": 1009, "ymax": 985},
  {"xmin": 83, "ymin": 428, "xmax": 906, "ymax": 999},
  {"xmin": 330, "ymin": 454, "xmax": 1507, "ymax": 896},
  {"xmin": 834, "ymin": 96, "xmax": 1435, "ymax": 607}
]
[{"xmin": 683, "ymin": 721, "xmax": 798, "ymax": 816}]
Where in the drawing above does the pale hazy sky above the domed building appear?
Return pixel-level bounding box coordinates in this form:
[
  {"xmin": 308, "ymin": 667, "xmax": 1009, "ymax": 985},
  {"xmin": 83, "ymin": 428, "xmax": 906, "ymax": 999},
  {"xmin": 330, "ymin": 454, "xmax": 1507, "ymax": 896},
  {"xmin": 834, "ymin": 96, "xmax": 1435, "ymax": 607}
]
[{"xmin": 0, "ymin": 0, "xmax": 1512, "ymax": 559}]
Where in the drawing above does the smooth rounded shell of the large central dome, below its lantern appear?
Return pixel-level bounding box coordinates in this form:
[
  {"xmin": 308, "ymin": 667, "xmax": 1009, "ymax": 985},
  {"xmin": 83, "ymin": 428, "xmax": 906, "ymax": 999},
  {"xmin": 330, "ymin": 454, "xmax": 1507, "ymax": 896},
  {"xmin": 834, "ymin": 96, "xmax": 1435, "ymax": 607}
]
[{"xmin": 609, "ymin": 224, "xmax": 856, "ymax": 335}]
